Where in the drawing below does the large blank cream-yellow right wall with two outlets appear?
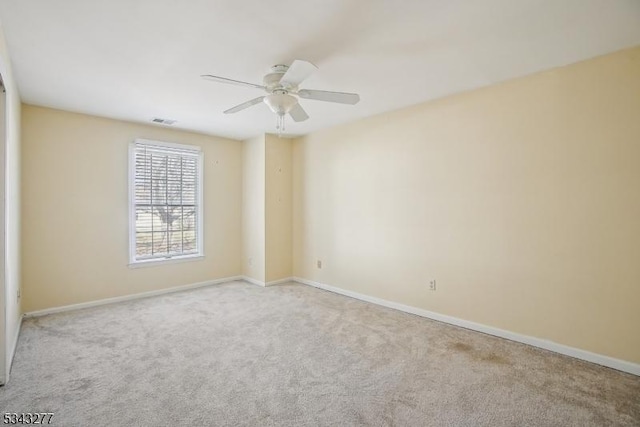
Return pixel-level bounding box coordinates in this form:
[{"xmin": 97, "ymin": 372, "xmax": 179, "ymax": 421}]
[{"xmin": 293, "ymin": 48, "xmax": 640, "ymax": 363}]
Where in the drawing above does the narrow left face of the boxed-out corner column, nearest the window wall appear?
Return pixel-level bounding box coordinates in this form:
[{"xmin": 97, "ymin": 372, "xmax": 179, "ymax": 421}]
[{"xmin": 242, "ymin": 135, "xmax": 266, "ymax": 283}]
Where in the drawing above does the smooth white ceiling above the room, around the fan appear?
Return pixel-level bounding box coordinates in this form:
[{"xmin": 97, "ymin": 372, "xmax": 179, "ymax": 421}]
[{"xmin": 0, "ymin": 0, "xmax": 640, "ymax": 139}]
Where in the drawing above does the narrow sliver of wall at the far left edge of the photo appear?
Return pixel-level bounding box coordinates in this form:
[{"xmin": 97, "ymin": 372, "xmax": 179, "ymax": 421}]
[{"xmin": 0, "ymin": 18, "xmax": 22, "ymax": 383}]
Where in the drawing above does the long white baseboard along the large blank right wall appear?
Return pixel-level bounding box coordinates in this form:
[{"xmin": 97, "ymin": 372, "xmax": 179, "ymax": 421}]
[{"xmin": 293, "ymin": 277, "xmax": 640, "ymax": 376}]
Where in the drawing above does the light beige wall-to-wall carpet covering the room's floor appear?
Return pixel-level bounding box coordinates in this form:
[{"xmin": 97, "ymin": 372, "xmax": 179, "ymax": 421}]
[{"xmin": 0, "ymin": 282, "xmax": 640, "ymax": 426}]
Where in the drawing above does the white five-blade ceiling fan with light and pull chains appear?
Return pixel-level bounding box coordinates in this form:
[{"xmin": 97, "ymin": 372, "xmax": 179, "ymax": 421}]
[{"xmin": 201, "ymin": 59, "xmax": 360, "ymax": 134}]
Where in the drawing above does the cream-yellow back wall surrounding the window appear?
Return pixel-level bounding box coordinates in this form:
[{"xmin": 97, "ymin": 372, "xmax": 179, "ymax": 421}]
[{"xmin": 22, "ymin": 105, "xmax": 242, "ymax": 312}]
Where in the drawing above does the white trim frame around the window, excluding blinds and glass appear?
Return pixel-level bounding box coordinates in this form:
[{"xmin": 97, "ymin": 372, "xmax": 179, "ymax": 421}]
[{"xmin": 128, "ymin": 138, "xmax": 204, "ymax": 268}]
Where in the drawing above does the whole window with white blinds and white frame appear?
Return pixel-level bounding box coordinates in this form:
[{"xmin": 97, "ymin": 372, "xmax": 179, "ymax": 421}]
[{"xmin": 129, "ymin": 139, "xmax": 203, "ymax": 264}]
